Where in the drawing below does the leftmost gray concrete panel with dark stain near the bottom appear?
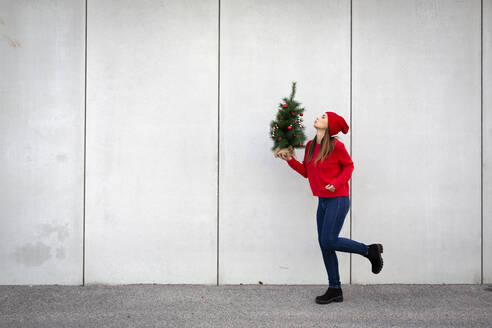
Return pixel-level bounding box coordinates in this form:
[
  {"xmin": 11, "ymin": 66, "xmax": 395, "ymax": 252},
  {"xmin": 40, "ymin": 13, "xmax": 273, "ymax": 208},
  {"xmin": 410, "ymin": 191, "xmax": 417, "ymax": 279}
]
[{"xmin": 0, "ymin": 0, "xmax": 85, "ymax": 285}]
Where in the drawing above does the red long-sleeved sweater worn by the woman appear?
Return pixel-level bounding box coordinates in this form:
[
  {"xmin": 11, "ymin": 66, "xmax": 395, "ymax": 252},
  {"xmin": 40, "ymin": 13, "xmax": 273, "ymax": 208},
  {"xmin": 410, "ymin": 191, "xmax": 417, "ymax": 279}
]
[{"xmin": 287, "ymin": 139, "xmax": 354, "ymax": 197}]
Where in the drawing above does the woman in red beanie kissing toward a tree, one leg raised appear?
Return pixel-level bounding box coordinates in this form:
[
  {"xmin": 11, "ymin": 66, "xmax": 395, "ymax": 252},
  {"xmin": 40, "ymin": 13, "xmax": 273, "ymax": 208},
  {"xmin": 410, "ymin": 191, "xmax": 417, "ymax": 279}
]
[{"xmin": 281, "ymin": 112, "xmax": 383, "ymax": 304}]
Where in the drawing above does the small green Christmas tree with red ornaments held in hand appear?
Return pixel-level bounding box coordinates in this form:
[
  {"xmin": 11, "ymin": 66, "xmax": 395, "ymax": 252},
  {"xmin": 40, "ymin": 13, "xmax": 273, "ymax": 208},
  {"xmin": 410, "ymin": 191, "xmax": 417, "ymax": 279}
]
[{"xmin": 270, "ymin": 82, "xmax": 306, "ymax": 157}]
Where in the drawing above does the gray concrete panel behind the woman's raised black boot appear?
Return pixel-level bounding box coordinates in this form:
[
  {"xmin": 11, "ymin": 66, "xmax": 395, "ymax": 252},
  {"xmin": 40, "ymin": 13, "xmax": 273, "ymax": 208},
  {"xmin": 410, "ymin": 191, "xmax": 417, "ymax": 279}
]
[{"xmin": 352, "ymin": 0, "xmax": 481, "ymax": 283}]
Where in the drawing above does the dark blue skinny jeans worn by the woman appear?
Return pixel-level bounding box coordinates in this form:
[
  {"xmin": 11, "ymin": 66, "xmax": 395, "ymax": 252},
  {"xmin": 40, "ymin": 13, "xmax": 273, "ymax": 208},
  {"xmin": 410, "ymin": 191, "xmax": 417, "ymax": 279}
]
[{"xmin": 316, "ymin": 196, "xmax": 369, "ymax": 288}]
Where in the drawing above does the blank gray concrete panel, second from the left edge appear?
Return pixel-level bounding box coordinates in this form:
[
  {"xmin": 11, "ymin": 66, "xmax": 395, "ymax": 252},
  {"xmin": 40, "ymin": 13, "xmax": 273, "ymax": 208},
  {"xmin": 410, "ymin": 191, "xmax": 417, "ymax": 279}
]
[{"xmin": 85, "ymin": 0, "xmax": 218, "ymax": 284}]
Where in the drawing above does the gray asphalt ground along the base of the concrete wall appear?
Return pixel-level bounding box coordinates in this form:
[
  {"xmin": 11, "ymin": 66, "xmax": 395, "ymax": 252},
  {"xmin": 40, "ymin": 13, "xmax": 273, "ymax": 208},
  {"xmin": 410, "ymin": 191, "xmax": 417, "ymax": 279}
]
[{"xmin": 0, "ymin": 284, "xmax": 492, "ymax": 328}]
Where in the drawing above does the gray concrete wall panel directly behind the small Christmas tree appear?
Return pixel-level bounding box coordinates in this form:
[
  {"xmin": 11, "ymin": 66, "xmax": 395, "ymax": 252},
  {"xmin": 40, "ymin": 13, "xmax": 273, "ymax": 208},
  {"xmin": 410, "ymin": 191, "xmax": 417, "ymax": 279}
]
[{"xmin": 219, "ymin": 0, "xmax": 350, "ymax": 284}]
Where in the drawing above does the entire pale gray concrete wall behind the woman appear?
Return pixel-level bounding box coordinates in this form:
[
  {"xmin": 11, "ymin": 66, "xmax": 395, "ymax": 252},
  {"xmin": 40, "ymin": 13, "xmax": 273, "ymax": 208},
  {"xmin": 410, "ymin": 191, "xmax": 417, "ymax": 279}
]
[{"xmin": 0, "ymin": 0, "xmax": 492, "ymax": 284}]
